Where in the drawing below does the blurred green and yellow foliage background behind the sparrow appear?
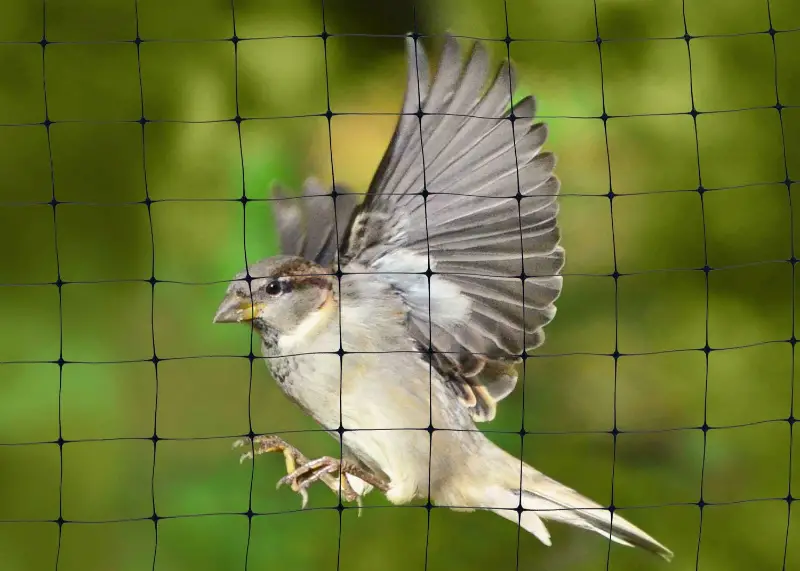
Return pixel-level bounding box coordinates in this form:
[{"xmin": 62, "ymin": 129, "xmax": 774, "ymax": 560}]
[{"xmin": 0, "ymin": 0, "xmax": 800, "ymax": 571}]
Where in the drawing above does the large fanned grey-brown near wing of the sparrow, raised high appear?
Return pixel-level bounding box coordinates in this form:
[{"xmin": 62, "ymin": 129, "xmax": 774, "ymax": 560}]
[{"xmin": 334, "ymin": 37, "xmax": 564, "ymax": 420}]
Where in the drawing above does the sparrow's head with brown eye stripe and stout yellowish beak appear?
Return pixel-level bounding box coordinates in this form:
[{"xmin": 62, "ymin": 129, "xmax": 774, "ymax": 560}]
[{"xmin": 214, "ymin": 256, "xmax": 336, "ymax": 341}]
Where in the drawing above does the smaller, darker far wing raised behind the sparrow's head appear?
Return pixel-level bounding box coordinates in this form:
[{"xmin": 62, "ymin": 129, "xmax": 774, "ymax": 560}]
[{"xmin": 272, "ymin": 179, "xmax": 360, "ymax": 267}]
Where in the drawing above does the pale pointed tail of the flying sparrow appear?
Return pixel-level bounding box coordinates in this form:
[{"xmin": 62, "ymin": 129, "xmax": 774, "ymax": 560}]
[{"xmin": 466, "ymin": 450, "xmax": 672, "ymax": 561}]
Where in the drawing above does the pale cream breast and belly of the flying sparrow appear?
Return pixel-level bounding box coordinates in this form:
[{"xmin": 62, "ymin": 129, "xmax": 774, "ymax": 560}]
[{"xmin": 270, "ymin": 276, "xmax": 442, "ymax": 502}]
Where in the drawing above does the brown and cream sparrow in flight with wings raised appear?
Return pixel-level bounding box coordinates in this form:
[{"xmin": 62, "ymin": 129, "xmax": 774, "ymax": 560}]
[{"xmin": 214, "ymin": 35, "xmax": 673, "ymax": 560}]
